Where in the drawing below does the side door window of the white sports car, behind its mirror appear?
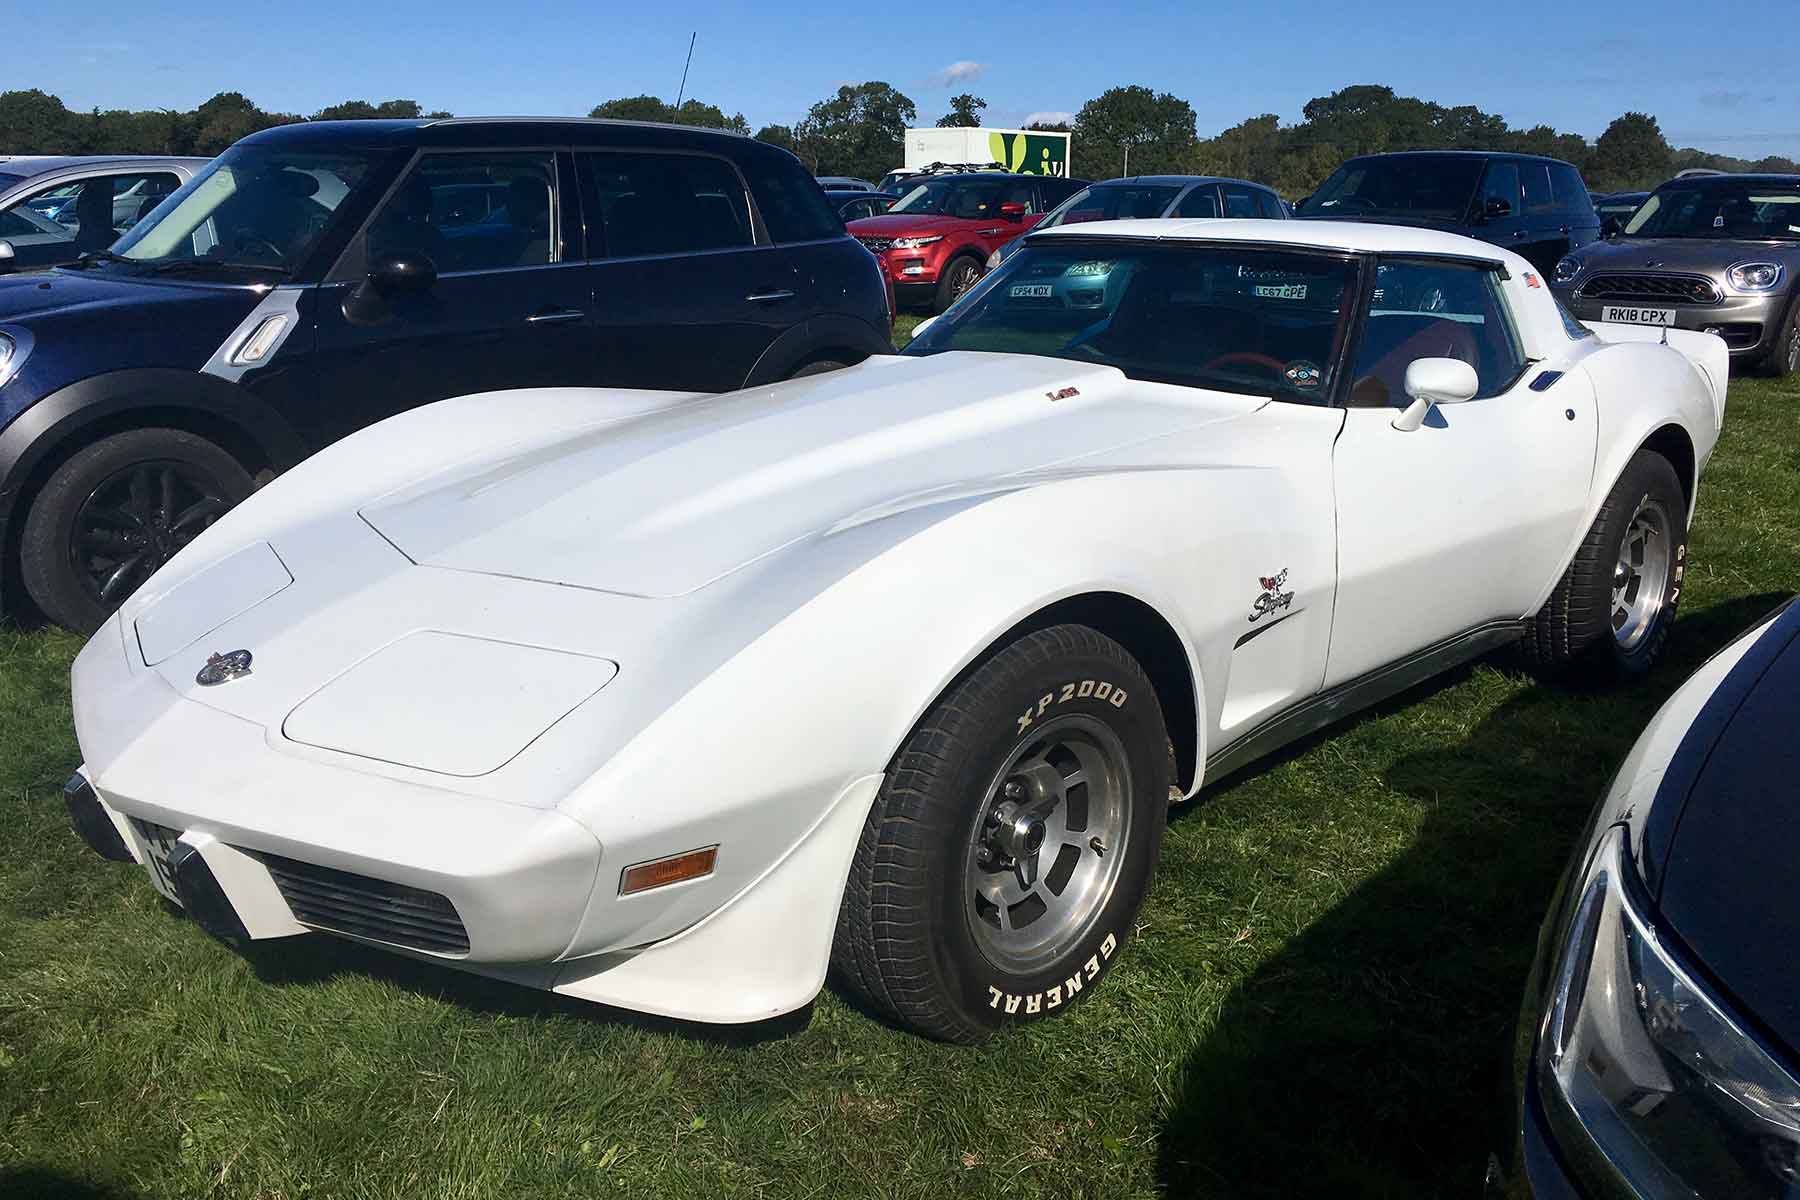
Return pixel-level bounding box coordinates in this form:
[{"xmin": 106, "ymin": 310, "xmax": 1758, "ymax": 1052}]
[{"xmin": 1350, "ymin": 261, "xmax": 1525, "ymax": 408}]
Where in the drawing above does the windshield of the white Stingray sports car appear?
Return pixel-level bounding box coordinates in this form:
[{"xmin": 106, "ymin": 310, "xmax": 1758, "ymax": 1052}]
[{"xmin": 904, "ymin": 236, "xmax": 1355, "ymax": 403}]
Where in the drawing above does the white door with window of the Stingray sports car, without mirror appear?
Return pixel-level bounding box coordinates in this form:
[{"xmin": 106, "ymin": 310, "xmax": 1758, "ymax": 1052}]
[{"xmin": 1325, "ymin": 259, "xmax": 1597, "ymax": 687}]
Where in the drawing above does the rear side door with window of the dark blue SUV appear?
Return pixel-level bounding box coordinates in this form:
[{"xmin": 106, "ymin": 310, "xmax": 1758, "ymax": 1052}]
[{"xmin": 576, "ymin": 149, "xmax": 799, "ymax": 392}]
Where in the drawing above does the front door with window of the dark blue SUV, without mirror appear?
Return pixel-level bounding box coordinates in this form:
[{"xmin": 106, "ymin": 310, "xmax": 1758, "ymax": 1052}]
[{"xmin": 306, "ymin": 149, "xmax": 594, "ymax": 441}]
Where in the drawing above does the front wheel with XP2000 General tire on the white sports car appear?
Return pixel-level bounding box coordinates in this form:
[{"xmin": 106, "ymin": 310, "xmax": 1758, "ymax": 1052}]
[{"xmin": 832, "ymin": 624, "xmax": 1170, "ymax": 1042}]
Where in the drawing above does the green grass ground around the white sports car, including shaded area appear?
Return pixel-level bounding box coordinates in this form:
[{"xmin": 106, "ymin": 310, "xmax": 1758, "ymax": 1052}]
[{"xmin": 0, "ymin": 370, "xmax": 1800, "ymax": 1200}]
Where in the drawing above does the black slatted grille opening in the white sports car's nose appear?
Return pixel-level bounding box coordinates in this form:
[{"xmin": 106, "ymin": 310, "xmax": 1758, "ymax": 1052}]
[{"xmin": 261, "ymin": 851, "xmax": 468, "ymax": 954}]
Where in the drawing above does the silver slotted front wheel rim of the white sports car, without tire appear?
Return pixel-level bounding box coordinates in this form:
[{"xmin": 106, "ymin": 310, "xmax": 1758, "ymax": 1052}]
[{"xmin": 963, "ymin": 714, "xmax": 1132, "ymax": 975}]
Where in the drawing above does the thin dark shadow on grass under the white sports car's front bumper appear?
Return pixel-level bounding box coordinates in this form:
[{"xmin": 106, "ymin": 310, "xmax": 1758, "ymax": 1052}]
[{"xmin": 230, "ymin": 928, "xmax": 812, "ymax": 1043}]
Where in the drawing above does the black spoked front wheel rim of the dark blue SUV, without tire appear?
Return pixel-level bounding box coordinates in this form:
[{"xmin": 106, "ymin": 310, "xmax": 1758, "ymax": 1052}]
[{"xmin": 68, "ymin": 459, "xmax": 230, "ymax": 608}]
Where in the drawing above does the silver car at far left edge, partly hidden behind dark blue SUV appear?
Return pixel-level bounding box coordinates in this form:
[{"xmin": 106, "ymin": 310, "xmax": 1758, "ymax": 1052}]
[{"xmin": 0, "ymin": 155, "xmax": 211, "ymax": 273}]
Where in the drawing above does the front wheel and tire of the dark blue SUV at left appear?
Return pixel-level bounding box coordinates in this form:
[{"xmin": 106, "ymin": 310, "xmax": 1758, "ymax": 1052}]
[{"xmin": 20, "ymin": 428, "xmax": 252, "ymax": 633}]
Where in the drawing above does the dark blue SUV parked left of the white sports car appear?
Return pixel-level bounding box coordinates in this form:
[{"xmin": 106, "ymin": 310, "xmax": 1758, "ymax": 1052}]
[{"xmin": 0, "ymin": 119, "xmax": 893, "ymax": 630}]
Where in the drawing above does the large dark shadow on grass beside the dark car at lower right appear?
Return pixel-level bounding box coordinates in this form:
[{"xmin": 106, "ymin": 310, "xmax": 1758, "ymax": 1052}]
[{"xmin": 1157, "ymin": 596, "xmax": 1786, "ymax": 1196}]
